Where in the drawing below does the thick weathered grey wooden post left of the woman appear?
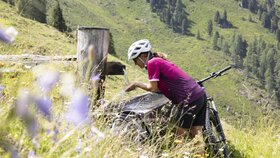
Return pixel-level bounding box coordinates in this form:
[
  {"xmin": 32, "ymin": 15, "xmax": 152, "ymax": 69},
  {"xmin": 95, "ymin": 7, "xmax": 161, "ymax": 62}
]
[{"xmin": 77, "ymin": 26, "xmax": 110, "ymax": 108}]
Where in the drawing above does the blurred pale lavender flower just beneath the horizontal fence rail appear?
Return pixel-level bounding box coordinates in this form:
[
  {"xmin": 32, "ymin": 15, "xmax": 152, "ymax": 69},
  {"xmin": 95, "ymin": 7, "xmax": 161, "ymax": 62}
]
[{"xmin": 37, "ymin": 71, "xmax": 59, "ymax": 93}]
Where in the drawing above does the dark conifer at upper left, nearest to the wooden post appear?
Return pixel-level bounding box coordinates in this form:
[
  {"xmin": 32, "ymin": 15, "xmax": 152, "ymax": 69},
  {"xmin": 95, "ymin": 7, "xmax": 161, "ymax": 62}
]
[{"xmin": 48, "ymin": 2, "xmax": 67, "ymax": 32}]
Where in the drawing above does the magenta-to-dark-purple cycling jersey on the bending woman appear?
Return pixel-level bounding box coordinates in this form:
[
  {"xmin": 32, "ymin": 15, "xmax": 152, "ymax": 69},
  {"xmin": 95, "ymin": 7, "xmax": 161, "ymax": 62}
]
[{"xmin": 147, "ymin": 57, "xmax": 205, "ymax": 104}]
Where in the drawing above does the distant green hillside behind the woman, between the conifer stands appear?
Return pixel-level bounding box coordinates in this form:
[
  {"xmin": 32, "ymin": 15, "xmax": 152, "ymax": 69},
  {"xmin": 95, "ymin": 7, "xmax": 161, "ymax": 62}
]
[{"xmin": 56, "ymin": 0, "xmax": 280, "ymax": 123}]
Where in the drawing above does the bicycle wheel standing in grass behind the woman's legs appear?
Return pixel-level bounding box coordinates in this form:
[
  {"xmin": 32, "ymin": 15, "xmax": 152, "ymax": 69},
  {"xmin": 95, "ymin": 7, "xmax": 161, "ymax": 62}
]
[{"xmin": 205, "ymin": 108, "xmax": 229, "ymax": 158}]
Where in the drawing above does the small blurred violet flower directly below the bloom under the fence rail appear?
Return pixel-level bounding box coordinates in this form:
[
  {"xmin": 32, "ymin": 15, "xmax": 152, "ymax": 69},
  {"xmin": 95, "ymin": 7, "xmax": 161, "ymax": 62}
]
[{"xmin": 35, "ymin": 96, "xmax": 52, "ymax": 117}]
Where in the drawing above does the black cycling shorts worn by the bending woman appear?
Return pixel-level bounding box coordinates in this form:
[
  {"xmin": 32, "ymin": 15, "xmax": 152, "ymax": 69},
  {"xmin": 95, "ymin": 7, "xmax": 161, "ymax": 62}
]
[{"xmin": 174, "ymin": 94, "xmax": 207, "ymax": 129}]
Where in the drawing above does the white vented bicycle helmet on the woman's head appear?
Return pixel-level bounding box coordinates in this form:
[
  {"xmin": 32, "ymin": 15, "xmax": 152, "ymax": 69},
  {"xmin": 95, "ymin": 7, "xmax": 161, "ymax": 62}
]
[{"xmin": 128, "ymin": 39, "xmax": 152, "ymax": 60}]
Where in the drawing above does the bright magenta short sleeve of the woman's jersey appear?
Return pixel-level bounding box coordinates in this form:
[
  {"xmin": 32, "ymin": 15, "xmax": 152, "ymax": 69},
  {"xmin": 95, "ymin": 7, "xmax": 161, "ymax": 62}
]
[{"xmin": 147, "ymin": 60, "xmax": 160, "ymax": 81}]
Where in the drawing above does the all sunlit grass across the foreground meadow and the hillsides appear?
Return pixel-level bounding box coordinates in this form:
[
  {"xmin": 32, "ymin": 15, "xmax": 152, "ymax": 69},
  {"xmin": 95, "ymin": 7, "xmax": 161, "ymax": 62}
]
[{"xmin": 0, "ymin": 0, "xmax": 280, "ymax": 157}]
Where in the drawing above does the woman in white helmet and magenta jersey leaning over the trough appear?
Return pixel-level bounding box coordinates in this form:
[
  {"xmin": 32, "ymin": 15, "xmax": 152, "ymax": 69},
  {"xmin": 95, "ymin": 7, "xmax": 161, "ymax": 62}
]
[{"xmin": 126, "ymin": 39, "xmax": 206, "ymax": 138}]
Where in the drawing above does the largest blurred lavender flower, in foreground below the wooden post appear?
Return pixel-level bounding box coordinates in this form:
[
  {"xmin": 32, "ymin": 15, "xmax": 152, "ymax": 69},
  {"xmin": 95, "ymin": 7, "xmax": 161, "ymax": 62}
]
[{"xmin": 66, "ymin": 90, "xmax": 89, "ymax": 125}]
